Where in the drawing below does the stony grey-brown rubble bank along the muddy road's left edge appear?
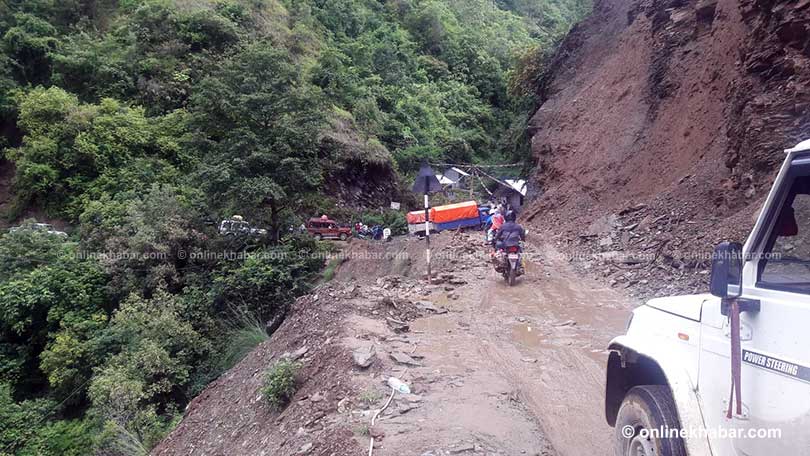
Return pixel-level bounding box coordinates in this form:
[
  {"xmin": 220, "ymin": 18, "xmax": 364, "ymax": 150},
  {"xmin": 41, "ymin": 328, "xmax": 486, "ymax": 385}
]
[{"xmin": 152, "ymin": 234, "xmax": 486, "ymax": 456}]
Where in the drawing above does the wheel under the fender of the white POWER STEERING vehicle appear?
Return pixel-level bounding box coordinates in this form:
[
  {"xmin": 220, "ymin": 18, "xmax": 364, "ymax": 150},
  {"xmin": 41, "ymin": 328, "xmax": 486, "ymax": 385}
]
[{"xmin": 615, "ymin": 385, "xmax": 686, "ymax": 456}]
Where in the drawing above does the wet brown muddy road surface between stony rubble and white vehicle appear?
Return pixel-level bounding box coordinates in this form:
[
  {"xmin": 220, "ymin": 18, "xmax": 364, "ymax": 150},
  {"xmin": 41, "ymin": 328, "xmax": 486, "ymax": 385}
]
[{"xmin": 375, "ymin": 239, "xmax": 636, "ymax": 456}]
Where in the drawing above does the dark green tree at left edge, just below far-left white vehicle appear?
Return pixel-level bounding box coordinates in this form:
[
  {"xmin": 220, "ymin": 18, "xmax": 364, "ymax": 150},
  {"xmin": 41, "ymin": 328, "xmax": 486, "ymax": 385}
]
[{"xmin": 0, "ymin": 231, "xmax": 109, "ymax": 401}]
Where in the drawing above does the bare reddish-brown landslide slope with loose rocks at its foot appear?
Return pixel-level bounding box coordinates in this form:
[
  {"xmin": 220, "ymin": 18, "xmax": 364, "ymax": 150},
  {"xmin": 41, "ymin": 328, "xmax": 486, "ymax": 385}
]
[{"xmin": 525, "ymin": 0, "xmax": 810, "ymax": 295}]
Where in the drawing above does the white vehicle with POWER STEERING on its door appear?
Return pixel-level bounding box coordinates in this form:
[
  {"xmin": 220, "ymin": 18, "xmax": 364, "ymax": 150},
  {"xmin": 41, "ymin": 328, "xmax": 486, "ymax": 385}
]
[{"xmin": 605, "ymin": 140, "xmax": 810, "ymax": 456}]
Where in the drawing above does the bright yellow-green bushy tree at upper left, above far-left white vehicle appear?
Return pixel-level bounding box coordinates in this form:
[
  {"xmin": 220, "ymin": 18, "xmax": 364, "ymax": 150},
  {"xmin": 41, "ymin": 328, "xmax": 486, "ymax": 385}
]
[{"xmin": 7, "ymin": 87, "xmax": 188, "ymax": 218}]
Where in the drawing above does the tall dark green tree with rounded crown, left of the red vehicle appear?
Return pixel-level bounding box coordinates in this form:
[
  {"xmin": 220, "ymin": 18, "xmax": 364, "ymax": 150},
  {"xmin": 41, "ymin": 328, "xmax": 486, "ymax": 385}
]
[{"xmin": 192, "ymin": 45, "xmax": 324, "ymax": 239}]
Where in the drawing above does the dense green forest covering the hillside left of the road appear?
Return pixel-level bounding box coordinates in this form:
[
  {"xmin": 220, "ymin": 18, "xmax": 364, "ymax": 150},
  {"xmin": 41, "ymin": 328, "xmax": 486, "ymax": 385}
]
[{"xmin": 0, "ymin": 0, "xmax": 589, "ymax": 455}]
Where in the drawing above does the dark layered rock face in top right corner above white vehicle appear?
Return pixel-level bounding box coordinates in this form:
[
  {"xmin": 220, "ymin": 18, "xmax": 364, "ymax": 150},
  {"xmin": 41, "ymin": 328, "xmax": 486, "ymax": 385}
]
[{"xmin": 726, "ymin": 0, "xmax": 810, "ymax": 175}]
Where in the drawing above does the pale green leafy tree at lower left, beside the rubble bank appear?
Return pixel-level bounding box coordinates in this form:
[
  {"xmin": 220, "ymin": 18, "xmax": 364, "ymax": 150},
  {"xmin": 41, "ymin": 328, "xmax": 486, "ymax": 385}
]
[{"xmin": 89, "ymin": 290, "xmax": 212, "ymax": 448}]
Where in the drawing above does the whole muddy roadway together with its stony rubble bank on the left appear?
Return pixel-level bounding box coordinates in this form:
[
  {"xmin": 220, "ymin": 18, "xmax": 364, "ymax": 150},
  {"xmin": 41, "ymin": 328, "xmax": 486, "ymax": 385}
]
[{"xmin": 152, "ymin": 233, "xmax": 633, "ymax": 456}]
